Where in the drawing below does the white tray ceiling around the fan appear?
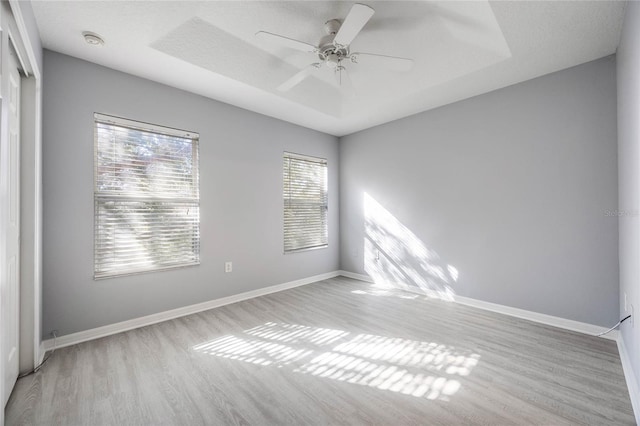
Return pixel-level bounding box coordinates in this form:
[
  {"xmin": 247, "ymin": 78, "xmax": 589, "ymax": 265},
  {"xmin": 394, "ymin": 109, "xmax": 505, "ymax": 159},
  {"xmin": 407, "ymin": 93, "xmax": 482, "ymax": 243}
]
[{"xmin": 32, "ymin": 0, "xmax": 625, "ymax": 136}]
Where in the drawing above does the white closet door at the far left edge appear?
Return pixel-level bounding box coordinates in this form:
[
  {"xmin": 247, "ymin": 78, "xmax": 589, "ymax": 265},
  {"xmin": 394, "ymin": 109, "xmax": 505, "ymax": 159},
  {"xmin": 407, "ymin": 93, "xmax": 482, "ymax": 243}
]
[{"xmin": 0, "ymin": 48, "xmax": 20, "ymax": 407}]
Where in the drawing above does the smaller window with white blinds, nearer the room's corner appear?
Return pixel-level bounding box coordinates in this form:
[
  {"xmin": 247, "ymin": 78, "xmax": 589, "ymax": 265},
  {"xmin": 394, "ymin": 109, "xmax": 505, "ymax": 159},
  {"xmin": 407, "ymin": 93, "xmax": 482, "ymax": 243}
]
[{"xmin": 283, "ymin": 152, "xmax": 327, "ymax": 253}]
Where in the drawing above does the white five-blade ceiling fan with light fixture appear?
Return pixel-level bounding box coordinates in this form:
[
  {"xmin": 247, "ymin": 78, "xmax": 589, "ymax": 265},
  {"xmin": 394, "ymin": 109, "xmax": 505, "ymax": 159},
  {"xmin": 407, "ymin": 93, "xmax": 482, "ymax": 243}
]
[{"xmin": 256, "ymin": 3, "xmax": 413, "ymax": 94}]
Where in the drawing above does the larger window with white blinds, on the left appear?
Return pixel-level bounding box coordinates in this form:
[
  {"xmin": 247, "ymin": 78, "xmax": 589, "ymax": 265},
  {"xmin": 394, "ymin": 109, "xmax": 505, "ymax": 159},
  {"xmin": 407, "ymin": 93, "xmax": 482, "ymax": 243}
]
[{"xmin": 94, "ymin": 114, "xmax": 200, "ymax": 279}]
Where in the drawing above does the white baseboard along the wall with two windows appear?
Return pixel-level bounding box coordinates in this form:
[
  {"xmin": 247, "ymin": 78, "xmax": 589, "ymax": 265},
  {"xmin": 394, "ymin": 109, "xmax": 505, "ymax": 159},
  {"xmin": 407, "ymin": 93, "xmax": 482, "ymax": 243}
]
[{"xmin": 40, "ymin": 271, "xmax": 340, "ymax": 356}]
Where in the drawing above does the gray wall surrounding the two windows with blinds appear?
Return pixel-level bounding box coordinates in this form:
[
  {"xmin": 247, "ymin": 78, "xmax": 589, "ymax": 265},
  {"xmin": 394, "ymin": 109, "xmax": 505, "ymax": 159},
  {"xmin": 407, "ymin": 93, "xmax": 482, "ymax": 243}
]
[{"xmin": 43, "ymin": 51, "xmax": 339, "ymax": 337}]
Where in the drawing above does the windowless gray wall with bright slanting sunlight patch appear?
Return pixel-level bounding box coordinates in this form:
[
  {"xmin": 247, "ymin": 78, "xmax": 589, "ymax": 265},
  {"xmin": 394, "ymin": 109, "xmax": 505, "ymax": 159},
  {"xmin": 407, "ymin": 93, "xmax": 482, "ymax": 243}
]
[{"xmin": 340, "ymin": 57, "xmax": 618, "ymax": 326}]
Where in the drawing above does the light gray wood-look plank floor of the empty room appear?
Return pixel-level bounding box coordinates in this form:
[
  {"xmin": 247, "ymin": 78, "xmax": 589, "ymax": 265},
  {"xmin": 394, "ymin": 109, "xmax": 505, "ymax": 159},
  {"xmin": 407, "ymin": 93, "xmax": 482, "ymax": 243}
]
[{"xmin": 6, "ymin": 277, "xmax": 635, "ymax": 425}]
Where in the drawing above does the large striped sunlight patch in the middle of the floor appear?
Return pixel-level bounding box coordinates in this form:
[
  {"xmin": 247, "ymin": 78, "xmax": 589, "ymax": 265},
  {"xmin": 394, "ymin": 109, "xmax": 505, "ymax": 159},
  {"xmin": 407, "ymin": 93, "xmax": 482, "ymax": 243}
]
[{"xmin": 192, "ymin": 322, "xmax": 480, "ymax": 401}]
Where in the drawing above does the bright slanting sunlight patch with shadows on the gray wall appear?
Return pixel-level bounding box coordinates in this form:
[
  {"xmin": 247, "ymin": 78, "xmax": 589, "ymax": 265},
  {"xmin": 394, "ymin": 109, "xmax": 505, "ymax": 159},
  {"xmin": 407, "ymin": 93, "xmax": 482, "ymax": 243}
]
[{"xmin": 364, "ymin": 192, "xmax": 458, "ymax": 301}]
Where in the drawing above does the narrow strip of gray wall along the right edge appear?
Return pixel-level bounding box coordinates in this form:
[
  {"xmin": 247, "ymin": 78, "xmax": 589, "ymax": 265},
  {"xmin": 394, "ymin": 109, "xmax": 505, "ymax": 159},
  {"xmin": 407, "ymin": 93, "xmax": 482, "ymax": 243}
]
[{"xmin": 617, "ymin": 1, "xmax": 640, "ymax": 406}]
